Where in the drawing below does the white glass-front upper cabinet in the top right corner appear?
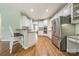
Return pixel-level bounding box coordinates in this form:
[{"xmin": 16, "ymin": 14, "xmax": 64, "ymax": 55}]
[{"xmin": 71, "ymin": 3, "xmax": 79, "ymax": 23}]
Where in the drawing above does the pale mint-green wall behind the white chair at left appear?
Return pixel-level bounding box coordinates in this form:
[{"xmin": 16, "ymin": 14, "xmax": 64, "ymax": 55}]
[{"xmin": 0, "ymin": 7, "xmax": 21, "ymax": 39}]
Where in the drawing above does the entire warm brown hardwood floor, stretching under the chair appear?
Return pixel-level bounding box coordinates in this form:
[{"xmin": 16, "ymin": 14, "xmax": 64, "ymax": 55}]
[{"xmin": 0, "ymin": 36, "xmax": 79, "ymax": 56}]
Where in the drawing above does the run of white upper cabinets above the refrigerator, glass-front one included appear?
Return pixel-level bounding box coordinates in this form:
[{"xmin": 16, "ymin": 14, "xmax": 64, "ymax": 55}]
[{"xmin": 52, "ymin": 3, "xmax": 79, "ymax": 24}]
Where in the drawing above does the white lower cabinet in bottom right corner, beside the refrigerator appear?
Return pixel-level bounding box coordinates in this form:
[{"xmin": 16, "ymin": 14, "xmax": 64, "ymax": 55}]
[{"xmin": 67, "ymin": 37, "xmax": 79, "ymax": 53}]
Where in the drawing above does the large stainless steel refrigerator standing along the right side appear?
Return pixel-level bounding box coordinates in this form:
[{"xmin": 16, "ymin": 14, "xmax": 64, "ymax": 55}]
[{"xmin": 52, "ymin": 15, "xmax": 75, "ymax": 51}]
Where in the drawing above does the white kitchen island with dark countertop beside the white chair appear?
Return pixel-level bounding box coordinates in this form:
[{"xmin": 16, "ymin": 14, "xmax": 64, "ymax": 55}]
[{"xmin": 16, "ymin": 28, "xmax": 37, "ymax": 49}]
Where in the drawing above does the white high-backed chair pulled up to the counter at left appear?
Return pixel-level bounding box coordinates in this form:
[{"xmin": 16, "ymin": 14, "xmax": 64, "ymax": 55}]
[{"xmin": 9, "ymin": 26, "xmax": 23, "ymax": 54}]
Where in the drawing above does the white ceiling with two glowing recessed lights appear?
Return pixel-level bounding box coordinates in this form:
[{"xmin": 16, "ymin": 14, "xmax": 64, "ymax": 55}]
[{"xmin": 0, "ymin": 3, "xmax": 66, "ymax": 20}]
